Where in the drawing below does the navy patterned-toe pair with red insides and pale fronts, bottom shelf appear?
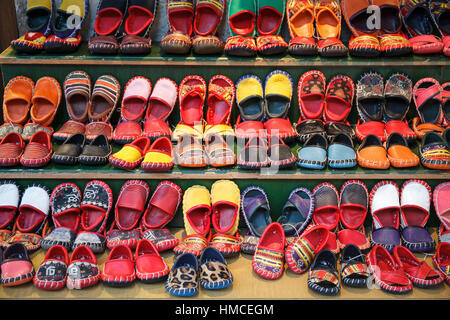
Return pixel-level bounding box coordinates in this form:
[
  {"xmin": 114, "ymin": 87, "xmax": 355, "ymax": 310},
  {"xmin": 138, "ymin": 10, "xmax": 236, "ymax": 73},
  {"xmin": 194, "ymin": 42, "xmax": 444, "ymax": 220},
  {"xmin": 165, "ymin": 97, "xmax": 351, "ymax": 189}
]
[{"xmin": 41, "ymin": 180, "xmax": 113, "ymax": 253}]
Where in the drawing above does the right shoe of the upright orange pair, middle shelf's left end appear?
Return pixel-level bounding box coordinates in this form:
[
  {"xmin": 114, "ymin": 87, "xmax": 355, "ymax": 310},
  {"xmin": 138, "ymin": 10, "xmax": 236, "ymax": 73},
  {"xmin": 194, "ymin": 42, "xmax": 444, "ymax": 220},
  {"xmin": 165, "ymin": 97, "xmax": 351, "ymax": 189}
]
[{"xmin": 30, "ymin": 77, "xmax": 62, "ymax": 126}]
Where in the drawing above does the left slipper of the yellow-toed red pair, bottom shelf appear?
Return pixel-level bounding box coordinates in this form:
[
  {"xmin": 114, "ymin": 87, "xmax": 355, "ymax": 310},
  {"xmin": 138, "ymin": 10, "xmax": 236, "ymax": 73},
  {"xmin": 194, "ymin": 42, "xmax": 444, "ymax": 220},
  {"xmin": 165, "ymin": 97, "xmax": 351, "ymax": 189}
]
[{"xmin": 183, "ymin": 185, "xmax": 211, "ymax": 236}]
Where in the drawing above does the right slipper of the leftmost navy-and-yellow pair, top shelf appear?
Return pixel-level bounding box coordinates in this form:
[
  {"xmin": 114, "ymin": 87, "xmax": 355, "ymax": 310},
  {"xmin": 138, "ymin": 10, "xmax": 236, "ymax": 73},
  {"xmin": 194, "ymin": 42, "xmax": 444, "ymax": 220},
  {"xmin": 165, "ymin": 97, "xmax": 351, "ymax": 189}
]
[{"xmin": 44, "ymin": 0, "xmax": 89, "ymax": 53}]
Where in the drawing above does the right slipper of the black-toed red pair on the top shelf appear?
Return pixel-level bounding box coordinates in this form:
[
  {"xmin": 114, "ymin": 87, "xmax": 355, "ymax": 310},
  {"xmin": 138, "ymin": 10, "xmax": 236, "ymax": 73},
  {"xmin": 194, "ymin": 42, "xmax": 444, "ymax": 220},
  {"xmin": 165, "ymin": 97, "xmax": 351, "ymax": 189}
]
[{"xmin": 120, "ymin": 0, "xmax": 158, "ymax": 55}]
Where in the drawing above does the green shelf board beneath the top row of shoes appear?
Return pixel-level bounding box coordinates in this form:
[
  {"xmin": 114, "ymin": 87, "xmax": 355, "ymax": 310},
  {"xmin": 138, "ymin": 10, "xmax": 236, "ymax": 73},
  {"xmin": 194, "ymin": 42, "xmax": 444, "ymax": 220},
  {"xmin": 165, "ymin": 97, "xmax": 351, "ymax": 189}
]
[{"xmin": 0, "ymin": 43, "xmax": 450, "ymax": 67}]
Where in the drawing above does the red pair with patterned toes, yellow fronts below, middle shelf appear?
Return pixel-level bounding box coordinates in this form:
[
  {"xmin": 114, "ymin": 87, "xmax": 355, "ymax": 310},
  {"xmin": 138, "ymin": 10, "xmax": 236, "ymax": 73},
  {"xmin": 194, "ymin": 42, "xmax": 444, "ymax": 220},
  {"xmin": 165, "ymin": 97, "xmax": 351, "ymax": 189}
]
[{"xmin": 171, "ymin": 75, "xmax": 235, "ymax": 143}]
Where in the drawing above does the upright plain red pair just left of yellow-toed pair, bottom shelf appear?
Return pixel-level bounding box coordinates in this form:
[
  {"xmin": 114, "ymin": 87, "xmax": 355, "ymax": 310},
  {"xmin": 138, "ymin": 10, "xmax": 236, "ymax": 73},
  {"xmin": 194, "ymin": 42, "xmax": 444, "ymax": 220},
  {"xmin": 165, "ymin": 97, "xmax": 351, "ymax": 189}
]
[{"xmin": 106, "ymin": 180, "xmax": 183, "ymax": 251}]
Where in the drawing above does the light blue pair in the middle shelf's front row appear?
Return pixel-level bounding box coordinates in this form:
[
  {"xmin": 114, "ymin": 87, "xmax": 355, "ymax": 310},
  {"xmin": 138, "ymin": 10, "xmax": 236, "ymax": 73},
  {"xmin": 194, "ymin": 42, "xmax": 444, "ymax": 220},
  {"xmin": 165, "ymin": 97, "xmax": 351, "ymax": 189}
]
[{"xmin": 297, "ymin": 133, "xmax": 357, "ymax": 170}]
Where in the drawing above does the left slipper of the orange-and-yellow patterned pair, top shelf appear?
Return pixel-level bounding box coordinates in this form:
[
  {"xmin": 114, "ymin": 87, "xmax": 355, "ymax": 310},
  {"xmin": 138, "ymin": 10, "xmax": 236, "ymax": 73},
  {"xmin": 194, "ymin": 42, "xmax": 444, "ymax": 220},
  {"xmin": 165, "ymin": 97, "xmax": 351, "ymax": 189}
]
[{"xmin": 286, "ymin": 0, "xmax": 318, "ymax": 56}]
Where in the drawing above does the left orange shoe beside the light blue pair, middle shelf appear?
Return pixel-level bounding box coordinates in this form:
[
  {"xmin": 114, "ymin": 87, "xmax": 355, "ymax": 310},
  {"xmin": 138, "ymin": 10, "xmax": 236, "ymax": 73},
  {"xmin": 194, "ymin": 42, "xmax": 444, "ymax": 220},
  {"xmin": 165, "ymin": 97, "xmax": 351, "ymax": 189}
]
[{"xmin": 356, "ymin": 134, "xmax": 390, "ymax": 169}]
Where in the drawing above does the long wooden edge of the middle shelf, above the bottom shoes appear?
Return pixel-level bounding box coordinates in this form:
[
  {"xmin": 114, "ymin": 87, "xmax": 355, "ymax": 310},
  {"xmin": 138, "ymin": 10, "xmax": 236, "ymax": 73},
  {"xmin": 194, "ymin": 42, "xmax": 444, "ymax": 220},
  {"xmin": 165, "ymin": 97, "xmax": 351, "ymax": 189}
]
[{"xmin": 0, "ymin": 171, "xmax": 450, "ymax": 181}]
